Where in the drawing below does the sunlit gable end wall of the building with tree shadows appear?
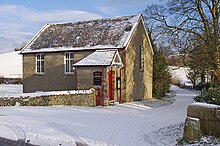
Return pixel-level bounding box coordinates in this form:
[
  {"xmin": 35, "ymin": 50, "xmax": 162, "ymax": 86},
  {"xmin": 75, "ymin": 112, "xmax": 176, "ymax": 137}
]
[{"xmin": 124, "ymin": 16, "xmax": 153, "ymax": 101}]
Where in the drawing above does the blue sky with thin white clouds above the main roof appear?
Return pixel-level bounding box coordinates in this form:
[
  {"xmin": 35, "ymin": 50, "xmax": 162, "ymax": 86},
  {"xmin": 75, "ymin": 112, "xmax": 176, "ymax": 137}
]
[{"xmin": 0, "ymin": 0, "xmax": 162, "ymax": 53}]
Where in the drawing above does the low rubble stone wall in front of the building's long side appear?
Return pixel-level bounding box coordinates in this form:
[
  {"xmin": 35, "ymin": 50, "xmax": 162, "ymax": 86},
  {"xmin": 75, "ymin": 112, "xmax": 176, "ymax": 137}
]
[{"xmin": 0, "ymin": 90, "xmax": 96, "ymax": 106}]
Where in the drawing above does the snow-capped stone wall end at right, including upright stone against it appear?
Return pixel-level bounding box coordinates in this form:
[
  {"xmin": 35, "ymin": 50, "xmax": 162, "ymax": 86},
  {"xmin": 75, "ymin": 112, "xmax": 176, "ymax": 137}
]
[{"xmin": 184, "ymin": 103, "xmax": 220, "ymax": 141}]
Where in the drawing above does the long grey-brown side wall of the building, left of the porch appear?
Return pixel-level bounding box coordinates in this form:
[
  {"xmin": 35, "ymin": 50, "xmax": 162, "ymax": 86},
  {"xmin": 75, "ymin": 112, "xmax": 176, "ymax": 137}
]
[{"xmin": 23, "ymin": 51, "xmax": 92, "ymax": 93}]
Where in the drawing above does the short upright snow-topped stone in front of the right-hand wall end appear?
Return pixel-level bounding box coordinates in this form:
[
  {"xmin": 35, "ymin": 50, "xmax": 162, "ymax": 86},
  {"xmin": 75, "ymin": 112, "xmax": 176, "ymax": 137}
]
[{"xmin": 183, "ymin": 117, "xmax": 201, "ymax": 143}]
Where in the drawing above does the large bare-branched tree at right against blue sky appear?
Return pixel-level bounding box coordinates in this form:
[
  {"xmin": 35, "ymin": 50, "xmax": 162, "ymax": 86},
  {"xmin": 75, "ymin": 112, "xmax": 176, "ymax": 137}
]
[{"xmin": 144, "ymin": 0, "xmax": 220, "ymax": 83}]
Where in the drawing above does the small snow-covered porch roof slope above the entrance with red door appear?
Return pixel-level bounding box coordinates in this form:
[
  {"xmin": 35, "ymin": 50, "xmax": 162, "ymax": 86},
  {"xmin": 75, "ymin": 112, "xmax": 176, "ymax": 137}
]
[{"xmin": 73, "ymin": 50, "xmax": 117, "ymax": 66}]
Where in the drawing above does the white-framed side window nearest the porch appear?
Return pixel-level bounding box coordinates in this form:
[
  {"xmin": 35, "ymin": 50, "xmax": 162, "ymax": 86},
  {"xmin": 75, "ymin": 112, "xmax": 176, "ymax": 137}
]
[{"xmin": 64, "ymin": 52, "xmax": 73, "ymax": 74}]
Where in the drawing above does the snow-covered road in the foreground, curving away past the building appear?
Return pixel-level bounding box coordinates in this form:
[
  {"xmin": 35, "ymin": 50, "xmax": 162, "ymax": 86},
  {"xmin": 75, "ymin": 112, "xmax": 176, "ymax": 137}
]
[{"xmin": 0, "ymin": 86, "xmax": 196, "ymax": 146}]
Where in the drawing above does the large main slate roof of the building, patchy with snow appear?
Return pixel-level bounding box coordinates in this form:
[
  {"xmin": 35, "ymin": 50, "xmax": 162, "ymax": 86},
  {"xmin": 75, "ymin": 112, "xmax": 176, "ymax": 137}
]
[{"xmin": 21, "ymin": 15, "xmax": 141, "ymax": 53}]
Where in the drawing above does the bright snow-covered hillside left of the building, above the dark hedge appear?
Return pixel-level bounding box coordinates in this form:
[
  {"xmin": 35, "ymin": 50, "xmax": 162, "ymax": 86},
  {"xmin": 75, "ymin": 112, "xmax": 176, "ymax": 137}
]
[{"xmin": 0, "ymin": 52, "xmax": 22, "ymax": 78}]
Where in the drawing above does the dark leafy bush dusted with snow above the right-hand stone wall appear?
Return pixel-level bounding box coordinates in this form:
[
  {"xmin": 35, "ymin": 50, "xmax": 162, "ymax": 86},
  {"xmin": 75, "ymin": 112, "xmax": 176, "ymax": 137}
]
[{"xmin": 194, "ymin": 86, "xmax": 220, "ymax": 105}]
